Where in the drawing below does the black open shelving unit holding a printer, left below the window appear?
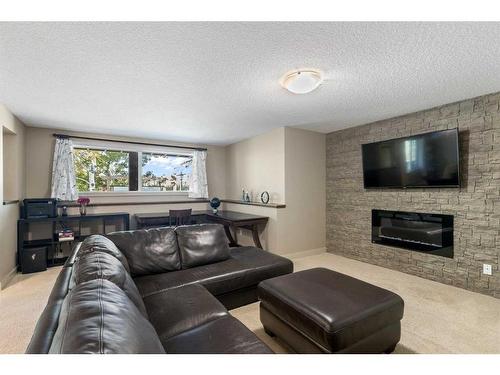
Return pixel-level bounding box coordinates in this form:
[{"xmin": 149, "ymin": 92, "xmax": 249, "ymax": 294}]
[{"xmin": 17, "ymin": 212, "xmax": 130, "ymax": 271}]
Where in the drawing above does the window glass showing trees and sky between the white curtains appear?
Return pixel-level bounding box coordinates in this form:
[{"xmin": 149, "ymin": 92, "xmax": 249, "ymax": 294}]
[{"xmin": 74, "ymin": 146, "xmax": 192, "ymax": 192}]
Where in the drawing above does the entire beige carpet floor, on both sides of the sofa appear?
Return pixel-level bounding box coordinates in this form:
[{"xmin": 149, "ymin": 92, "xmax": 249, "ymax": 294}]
[{"xmin": 0, "ymin": 254, "xmax": 500, "ymax": 353}]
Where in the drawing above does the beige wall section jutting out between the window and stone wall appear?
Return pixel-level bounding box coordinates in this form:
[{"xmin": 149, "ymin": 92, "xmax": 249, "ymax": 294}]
[{"xmin": 224, "ymin": 128, "xmax": 326, "ymax": 255}]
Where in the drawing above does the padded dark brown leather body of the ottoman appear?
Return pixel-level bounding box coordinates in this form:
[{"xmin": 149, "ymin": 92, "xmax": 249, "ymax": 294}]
[{"xmin": 258, "ymin": 268, "xmax": 404, "ymax": 352}]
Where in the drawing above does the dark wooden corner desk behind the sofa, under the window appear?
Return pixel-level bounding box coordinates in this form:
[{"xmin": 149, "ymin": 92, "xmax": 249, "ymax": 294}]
[{"xmin": 135, "ymin": 211, "xmax": 269, "ymax": 249}]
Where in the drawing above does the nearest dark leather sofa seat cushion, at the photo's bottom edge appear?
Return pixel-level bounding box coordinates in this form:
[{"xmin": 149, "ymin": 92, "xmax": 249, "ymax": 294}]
[{"xmin": 162, "ymin": 315, "xmax": 273, "ymax": 354}]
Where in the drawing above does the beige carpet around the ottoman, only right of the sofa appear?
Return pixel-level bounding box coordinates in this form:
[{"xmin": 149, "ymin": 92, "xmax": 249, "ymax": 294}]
[{"xmin": 231, "ymin": 253, "xmax": 500, "ymax": 354}]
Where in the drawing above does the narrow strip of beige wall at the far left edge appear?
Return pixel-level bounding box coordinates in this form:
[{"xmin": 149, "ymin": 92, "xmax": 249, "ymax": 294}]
[{"xmin": 0, "ymin": 104, "xmax": 25, "ymax": 289}]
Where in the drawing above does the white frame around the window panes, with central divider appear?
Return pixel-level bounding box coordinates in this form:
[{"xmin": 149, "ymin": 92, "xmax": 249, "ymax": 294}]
[{"xmin": 73, "ymin": 140, "xmax": 194, "ymax": 197}]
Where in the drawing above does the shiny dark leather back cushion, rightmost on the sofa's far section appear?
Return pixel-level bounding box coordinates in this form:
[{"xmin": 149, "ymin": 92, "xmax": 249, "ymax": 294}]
[{"xmin": 175, "ymin": 224, "xmax": 230, "ymax": 269}]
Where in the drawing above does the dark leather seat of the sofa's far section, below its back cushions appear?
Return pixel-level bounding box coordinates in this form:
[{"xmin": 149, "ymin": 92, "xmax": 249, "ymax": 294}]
[{"xmin": 134, "ymin": 247, "xmax": 293, "ymax": 298}]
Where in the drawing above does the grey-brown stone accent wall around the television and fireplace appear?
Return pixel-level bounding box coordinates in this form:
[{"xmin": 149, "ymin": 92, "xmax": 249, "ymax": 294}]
[{"xmin": 326, "ymin": 93, "xmax": 500, "ymax": 298}]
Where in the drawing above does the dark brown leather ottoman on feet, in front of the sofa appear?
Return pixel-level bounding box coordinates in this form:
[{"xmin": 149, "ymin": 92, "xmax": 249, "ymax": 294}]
[{"xmin": 258, "ymin": 268, "xmax": 404, "ymax": 353}]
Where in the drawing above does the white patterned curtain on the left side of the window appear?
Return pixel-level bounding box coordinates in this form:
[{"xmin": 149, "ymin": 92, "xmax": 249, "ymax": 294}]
[{"xmin": 51, "ymin": 138, "xmax": 78, "ymax": 201}]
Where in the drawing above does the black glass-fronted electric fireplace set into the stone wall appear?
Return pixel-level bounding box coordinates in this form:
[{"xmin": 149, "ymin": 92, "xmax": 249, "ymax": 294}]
[{"xmin": 372, "ymin": 210, "xmax": 453, "ymax": 258}]
